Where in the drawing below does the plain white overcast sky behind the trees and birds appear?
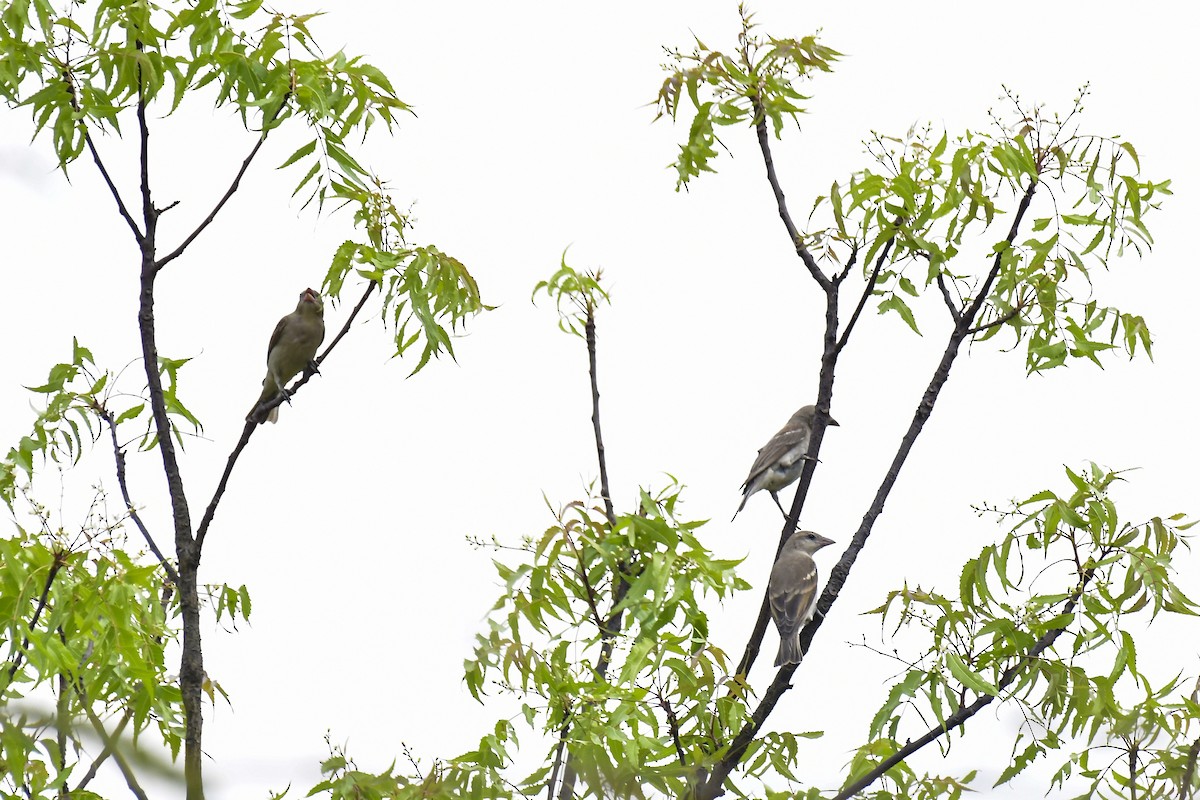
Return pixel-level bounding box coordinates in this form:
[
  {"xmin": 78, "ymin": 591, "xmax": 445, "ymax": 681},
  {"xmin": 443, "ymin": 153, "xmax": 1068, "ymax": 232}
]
[{"xmin": 0, "ymin": 0, "xmax": 1200, "ymax": 798}]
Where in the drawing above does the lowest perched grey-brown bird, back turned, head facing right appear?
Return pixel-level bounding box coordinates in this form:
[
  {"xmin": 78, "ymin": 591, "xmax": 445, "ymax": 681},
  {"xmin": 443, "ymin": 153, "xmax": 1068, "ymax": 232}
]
[{"xmin": 767, "ymin": 530, "xmax": 833, "ymax": 667}]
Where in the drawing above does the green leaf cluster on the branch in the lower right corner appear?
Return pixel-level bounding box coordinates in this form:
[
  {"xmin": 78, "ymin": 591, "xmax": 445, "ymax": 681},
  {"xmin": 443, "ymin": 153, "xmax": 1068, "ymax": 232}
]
[{"xmin": 847, "ymin": 464, "xmax": 1198, "ymax": 796}]
